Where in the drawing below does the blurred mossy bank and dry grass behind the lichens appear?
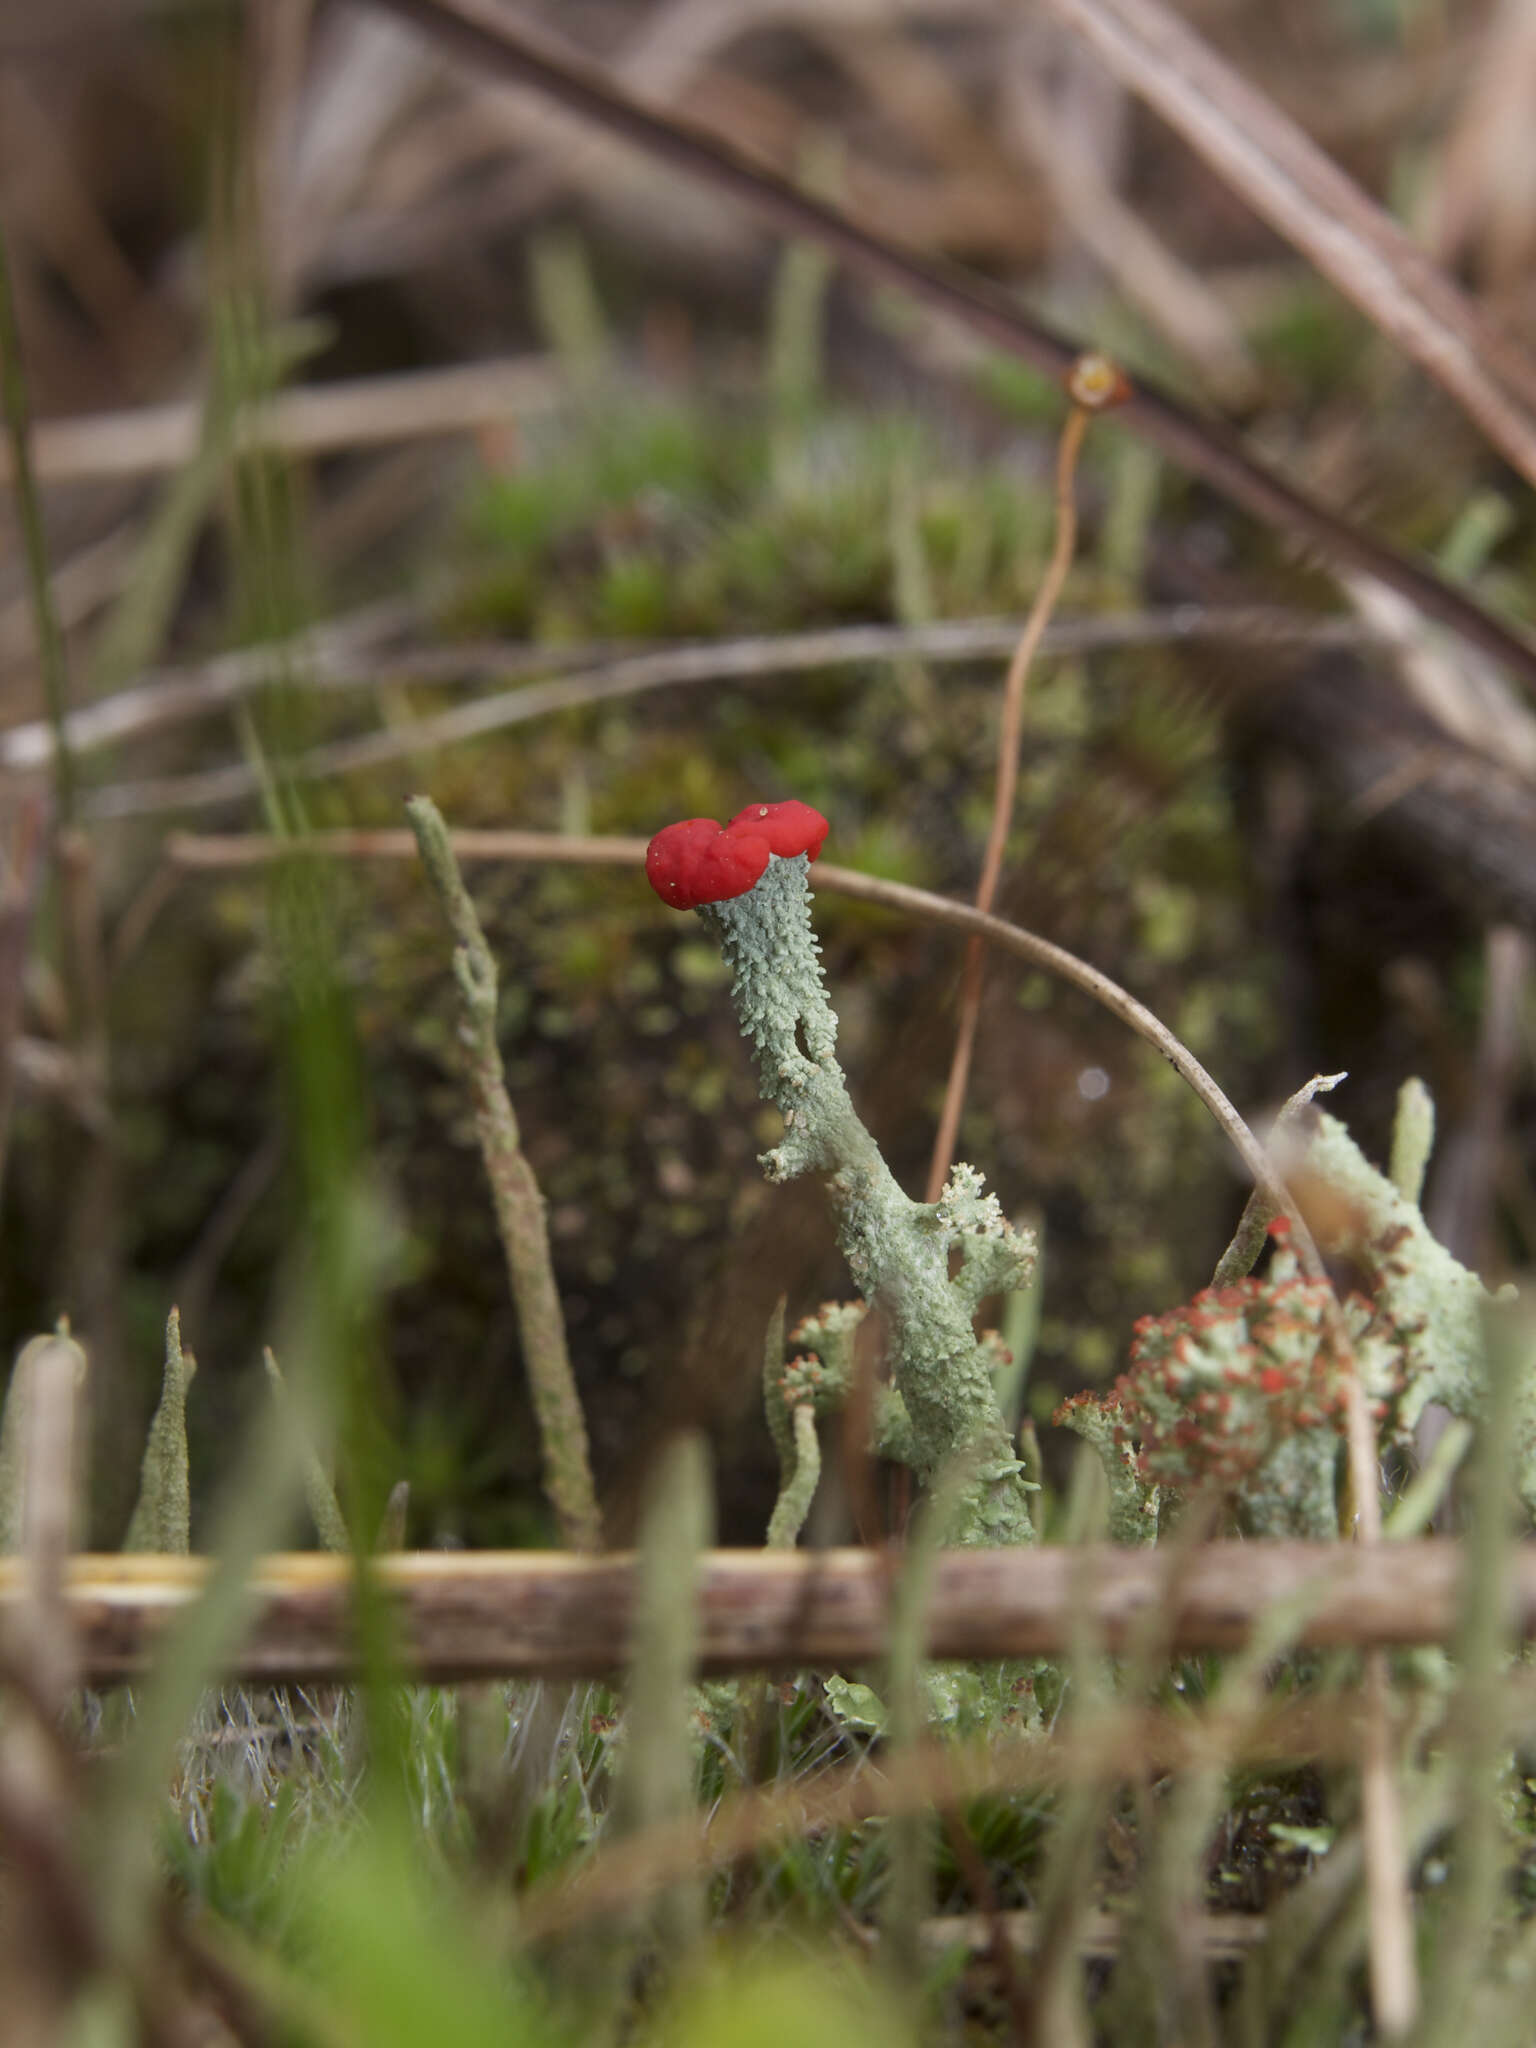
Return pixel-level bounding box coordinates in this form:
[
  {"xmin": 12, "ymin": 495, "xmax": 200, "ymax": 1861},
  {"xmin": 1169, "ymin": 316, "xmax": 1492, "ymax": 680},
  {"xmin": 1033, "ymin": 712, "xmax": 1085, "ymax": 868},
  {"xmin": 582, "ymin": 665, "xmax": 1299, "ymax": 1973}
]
[{"xmin": 0, "ymin": 0, "xmax": 1536, "ymax": 1544}]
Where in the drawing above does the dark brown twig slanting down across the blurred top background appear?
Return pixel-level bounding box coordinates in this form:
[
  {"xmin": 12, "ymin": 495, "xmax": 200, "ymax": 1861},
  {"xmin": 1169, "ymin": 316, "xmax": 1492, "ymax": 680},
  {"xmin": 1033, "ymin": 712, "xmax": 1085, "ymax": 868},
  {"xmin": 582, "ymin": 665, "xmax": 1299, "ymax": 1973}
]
[{"xmin": 360, "ymin": 0, "xmax": 1536, "ymax": 682}]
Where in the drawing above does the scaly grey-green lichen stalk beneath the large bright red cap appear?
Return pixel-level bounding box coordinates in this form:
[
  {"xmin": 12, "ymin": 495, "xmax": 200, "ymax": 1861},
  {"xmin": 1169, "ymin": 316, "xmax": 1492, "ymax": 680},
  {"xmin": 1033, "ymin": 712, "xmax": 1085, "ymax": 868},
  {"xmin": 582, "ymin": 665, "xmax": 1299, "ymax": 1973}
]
[{"xmin": 698, "ymin": 854, "xmax": 1034, "ymax": 1544}]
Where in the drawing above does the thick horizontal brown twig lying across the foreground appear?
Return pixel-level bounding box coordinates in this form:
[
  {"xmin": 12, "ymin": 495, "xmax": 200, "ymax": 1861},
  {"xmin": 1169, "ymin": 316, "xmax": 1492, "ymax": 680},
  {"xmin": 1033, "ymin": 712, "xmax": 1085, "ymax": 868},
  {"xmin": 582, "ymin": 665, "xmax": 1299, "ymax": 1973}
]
[{"xmin": 0, "ymin": 1538, "xmax": 1536, "ymax": 1679}]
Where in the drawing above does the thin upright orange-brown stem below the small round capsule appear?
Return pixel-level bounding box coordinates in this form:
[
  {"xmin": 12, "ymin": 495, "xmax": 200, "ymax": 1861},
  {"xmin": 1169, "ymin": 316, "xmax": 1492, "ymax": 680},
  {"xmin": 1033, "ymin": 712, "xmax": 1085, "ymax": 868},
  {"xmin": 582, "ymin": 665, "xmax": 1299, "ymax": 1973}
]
[{"xmin": 924, "ymin": 406, "xmax": 1090, "ymax": 1202}]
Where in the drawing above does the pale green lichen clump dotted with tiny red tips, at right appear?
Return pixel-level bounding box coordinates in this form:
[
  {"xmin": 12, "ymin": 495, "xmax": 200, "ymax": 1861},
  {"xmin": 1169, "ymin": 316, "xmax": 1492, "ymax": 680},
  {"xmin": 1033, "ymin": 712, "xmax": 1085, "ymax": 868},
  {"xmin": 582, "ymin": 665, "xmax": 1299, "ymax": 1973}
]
[{"xmin": 1057, "ymin": 1083, "xmax": 1536, "ymax": 1542}]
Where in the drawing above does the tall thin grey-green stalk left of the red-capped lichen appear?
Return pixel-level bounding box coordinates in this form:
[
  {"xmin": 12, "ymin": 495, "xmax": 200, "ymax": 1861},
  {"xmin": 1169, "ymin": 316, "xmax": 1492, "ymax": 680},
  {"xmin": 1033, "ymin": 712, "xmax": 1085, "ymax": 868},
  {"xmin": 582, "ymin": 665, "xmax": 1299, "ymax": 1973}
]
[{"xmin": 406, "ymin": 797, "xmax": 602, "ymax": 1550}]
